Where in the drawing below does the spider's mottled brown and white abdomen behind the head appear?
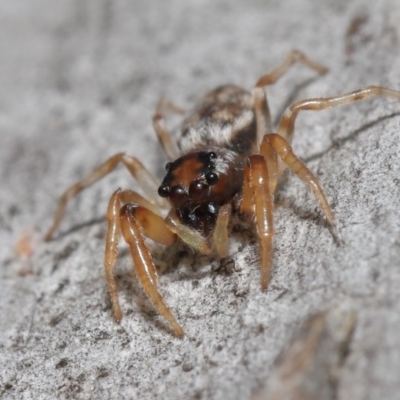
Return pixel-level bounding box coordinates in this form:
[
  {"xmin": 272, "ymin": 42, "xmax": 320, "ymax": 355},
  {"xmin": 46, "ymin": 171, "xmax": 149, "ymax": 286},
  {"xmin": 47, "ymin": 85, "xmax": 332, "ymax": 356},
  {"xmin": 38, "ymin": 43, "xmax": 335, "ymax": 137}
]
[{"xmin": 179, "ymin": 85, "xmax": 256, "ymax": 157}]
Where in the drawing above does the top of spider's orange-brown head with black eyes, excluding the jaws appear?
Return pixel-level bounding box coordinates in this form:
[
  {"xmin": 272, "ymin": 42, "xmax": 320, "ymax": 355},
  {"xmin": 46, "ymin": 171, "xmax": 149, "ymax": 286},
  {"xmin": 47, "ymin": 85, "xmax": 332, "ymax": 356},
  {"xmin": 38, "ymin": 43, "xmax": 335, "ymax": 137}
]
[{"xmin": 158, "ymin": 149, "xmax": 243, "ymax": 209}]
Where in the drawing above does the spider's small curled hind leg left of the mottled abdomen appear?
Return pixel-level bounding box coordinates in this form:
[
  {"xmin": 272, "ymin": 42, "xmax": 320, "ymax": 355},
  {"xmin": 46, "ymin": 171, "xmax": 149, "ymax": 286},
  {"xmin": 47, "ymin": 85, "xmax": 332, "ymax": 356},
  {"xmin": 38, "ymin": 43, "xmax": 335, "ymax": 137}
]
[{"xmin": 153, "ymin": 99, "xmax": 185, "ymax": 161}]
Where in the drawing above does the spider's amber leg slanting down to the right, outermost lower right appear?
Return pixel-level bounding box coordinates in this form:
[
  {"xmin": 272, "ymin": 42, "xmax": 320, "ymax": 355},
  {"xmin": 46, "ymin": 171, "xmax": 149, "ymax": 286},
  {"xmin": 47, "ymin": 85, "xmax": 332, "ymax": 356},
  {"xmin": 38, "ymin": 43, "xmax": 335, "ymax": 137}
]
[{"xmin": 264, "ymin": 133, "xmax": 334, "ymax": 225}]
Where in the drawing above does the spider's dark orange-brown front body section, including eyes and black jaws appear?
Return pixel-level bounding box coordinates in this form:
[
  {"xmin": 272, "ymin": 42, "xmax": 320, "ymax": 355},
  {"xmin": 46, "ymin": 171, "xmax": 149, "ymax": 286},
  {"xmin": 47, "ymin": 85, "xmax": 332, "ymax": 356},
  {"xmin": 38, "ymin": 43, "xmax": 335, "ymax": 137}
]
[{"xmin": 158, "ymin": 148, "xmax": 243, "ymax": 236}]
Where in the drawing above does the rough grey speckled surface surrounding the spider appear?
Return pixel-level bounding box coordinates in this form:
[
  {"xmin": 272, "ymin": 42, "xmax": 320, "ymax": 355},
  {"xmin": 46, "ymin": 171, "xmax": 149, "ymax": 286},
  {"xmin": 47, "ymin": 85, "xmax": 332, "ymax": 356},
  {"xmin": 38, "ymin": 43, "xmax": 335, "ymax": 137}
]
[{"xmin": 0, "ymin": 0, "xmax": 400, "ymax": 400}]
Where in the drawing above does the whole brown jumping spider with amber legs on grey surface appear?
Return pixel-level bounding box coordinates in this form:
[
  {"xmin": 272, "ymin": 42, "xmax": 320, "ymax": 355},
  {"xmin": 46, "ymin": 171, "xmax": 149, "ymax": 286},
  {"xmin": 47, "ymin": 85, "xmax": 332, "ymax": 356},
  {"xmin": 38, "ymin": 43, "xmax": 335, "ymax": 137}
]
[{"xmin": 45, "ymin": 51, "xmax": 400, "ymax": 336}]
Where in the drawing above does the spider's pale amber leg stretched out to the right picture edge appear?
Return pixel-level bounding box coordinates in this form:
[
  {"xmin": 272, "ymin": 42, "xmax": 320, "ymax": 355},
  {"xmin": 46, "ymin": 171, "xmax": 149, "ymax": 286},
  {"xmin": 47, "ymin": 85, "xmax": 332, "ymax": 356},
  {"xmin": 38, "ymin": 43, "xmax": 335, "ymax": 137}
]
[{"xmin": 278, "ymin": 86, "xmax": 400, "ymax": 143}]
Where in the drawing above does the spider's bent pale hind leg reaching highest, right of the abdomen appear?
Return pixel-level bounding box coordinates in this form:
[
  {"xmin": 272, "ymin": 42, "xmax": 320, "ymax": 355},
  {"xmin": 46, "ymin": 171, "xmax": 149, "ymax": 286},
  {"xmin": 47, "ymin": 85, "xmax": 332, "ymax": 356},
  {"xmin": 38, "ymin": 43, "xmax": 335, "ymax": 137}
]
[{"xmin": 253, "ymin": 50, "xmax": 327, "ymax": 139}]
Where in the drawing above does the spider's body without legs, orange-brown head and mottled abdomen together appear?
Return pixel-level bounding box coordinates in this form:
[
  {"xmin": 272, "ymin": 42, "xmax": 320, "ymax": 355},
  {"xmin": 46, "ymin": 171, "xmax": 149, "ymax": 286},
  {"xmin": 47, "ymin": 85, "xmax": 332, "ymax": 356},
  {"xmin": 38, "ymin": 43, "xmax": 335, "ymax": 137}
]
[{"xmin": 158, "ymin": 85, "xmax": 257, "ymax": 236}]
